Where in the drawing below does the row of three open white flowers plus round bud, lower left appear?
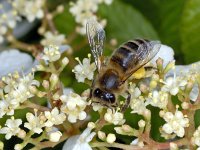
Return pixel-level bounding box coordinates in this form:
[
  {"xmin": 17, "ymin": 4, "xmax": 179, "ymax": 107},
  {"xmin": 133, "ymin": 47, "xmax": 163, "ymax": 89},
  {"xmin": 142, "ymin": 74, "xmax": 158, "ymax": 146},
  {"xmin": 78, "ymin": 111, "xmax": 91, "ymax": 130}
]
[{"xmin": 0, "ymin": 107, "xmax": 66, "ymax": 142}]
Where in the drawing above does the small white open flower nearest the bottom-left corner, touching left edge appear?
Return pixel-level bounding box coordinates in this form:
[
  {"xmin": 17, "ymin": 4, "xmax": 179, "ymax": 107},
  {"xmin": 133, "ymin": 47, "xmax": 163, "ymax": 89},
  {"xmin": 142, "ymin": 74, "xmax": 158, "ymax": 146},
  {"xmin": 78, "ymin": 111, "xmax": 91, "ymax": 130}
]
[{"xmin": 0, "ymin": 117, "xmax": 22, "ymax": 140}]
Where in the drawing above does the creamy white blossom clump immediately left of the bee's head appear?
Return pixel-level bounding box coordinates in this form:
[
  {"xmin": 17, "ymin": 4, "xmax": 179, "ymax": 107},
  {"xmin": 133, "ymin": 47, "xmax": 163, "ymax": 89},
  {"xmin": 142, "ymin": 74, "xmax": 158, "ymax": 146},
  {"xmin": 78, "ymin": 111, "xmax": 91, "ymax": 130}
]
[{"xmin": 60, "ymin": 92, "xmax": 88, "ymax": 123}]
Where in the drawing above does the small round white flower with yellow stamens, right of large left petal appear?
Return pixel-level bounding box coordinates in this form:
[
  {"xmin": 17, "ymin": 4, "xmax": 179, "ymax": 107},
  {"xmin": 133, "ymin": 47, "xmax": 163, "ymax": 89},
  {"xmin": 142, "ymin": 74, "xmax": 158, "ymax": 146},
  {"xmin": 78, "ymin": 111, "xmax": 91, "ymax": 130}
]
[{"xmin": 42, "ymin": 45, "xmax": 61, "ymax": 62}]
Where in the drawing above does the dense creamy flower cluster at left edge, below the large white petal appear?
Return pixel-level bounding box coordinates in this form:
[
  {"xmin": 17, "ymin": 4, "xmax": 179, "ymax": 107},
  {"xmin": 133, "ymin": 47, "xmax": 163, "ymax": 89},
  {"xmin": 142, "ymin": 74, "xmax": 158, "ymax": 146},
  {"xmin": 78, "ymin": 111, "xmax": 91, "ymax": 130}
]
[{"xmin": 0, "ymin": 73, "xmax": 39, "ymax": 118}]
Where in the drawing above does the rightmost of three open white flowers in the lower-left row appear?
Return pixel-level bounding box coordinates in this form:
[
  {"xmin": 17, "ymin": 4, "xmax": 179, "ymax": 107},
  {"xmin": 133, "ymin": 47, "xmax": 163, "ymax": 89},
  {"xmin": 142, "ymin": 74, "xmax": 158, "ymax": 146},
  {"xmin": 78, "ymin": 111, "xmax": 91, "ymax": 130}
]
[{"xmin": 44, "ymin": 107, "xmax": 66, "ymax": 127}]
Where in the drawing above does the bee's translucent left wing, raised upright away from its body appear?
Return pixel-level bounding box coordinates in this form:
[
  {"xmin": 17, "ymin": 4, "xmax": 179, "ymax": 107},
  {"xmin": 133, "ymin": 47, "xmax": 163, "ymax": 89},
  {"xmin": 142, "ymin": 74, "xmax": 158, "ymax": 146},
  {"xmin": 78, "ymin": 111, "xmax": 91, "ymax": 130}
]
[{"xmin": 86, "ymin": 19, "xmax": 105, "ymax": 71}]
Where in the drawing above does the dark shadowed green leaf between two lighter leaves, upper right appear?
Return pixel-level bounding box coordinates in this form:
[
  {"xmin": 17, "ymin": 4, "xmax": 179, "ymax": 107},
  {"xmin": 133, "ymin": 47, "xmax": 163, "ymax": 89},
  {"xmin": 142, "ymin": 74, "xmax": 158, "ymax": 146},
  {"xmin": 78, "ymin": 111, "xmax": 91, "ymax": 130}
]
[{"xmin": 125, "ymin": 0, "xmax": 185, "ymax": 63}]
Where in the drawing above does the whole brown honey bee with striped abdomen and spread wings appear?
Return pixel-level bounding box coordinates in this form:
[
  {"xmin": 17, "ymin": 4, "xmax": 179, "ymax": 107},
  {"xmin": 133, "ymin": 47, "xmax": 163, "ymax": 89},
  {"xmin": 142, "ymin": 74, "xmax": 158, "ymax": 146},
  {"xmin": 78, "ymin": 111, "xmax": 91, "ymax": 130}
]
[{"xmin": 86, "ymin": 20, "xmax": 161, "ymax": 111}]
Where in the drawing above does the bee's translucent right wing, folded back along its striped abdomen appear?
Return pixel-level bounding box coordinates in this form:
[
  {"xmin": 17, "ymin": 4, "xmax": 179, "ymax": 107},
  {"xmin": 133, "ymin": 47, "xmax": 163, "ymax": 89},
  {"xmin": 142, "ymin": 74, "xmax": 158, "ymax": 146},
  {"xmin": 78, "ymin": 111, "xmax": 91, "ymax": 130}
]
[{"xmin": 120, "ymin": 41, "xmax": 161, "ymax": 82}]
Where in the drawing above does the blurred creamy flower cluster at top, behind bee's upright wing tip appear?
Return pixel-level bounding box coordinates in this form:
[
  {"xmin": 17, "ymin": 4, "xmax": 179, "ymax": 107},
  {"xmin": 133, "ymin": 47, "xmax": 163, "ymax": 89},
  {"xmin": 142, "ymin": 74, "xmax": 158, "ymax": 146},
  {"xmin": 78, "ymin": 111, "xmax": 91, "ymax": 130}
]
[{"xmin": 69, "ymin": 0, "xmax": 112, "ymax": 34}]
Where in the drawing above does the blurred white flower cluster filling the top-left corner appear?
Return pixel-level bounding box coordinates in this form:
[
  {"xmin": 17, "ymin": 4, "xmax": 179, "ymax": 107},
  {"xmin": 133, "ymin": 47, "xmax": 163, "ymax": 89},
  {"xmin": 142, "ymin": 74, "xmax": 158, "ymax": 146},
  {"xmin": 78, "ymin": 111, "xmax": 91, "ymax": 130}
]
[{"xmin": 0, "ymin": 0, "xmax": 45, "ymax": 43}]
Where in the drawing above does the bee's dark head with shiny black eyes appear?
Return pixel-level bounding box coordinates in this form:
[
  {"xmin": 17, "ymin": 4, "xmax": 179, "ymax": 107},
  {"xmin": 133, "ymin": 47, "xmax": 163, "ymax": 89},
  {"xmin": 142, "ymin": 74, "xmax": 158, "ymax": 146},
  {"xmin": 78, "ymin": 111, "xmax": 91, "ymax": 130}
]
[{"xmin": 92, "ymin": 88, "xmax": 115, "ymax": 104}]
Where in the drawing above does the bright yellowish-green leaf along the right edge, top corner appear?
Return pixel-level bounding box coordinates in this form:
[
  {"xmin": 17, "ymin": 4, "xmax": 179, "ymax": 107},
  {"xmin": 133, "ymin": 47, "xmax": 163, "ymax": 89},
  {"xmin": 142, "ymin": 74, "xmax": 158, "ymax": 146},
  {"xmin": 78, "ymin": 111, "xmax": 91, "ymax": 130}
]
[{"xmin": 180, "ymin": 0, "xmax": 200, "ymax": 63}]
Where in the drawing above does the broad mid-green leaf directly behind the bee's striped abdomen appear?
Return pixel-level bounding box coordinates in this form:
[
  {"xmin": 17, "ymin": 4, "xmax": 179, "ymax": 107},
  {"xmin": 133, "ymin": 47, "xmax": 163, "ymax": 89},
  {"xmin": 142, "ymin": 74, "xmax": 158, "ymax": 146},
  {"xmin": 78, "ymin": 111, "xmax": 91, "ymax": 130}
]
[{"xmin": 99, "ymin": 0, "xmax": 159, "ymax": 43}]
